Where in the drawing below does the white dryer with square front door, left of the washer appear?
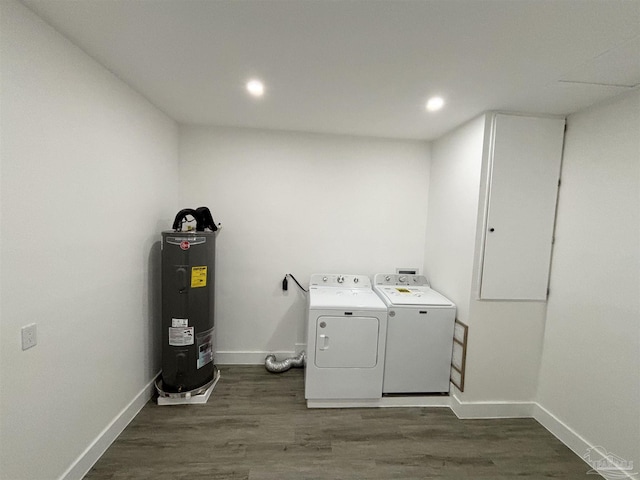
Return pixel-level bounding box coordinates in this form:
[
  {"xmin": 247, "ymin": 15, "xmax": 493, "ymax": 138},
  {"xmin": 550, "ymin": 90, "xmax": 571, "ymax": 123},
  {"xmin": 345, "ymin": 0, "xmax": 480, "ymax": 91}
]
[{"xmin": 305, "ymin": 274, "xmax": 387, "ymax": 401}]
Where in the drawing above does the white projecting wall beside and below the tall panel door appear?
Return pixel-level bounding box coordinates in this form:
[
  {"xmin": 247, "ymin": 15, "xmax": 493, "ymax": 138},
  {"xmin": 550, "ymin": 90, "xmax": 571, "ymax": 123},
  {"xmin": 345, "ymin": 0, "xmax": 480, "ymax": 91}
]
[{"xmin": 425, "ymin": 115, "xmax": 545, "ymax": 403}]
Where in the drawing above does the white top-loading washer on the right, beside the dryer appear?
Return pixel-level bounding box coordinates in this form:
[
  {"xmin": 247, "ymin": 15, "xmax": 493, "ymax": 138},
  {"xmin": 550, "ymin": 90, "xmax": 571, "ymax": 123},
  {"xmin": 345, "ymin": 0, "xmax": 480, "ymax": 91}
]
[{"xmin": 373, "ymin": 273, "xmax": 456, "ymax": 394}]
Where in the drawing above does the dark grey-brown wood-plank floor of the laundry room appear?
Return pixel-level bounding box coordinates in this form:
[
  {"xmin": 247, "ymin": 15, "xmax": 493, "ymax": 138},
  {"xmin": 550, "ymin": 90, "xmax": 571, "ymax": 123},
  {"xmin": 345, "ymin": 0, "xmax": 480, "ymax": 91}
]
[{"xmin": 85, "ymin": 366, "xmax": 599, "ymax": 480}]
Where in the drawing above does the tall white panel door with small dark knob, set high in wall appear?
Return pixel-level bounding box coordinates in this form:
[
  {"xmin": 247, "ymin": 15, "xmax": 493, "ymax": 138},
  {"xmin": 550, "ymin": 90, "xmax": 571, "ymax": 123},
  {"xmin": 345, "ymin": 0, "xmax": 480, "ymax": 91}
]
[{"xmin": 480, "ymin": 114, "xmax": 565, "ymax": 300}]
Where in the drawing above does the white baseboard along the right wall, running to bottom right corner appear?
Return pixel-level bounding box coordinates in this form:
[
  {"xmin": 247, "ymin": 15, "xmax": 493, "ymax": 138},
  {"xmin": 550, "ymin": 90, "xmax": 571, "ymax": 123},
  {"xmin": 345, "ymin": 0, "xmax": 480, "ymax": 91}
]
[{"xmin": 533, "ymin": 403, "xmax": 639, "ymax": 480}]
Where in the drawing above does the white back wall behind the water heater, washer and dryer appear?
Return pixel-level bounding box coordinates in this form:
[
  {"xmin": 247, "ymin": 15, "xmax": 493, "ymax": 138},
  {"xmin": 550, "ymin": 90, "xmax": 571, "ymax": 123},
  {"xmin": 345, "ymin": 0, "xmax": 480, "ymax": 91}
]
[{"xmin": 180, "ymin": 127, "xmax": 429, "ymax": 363}]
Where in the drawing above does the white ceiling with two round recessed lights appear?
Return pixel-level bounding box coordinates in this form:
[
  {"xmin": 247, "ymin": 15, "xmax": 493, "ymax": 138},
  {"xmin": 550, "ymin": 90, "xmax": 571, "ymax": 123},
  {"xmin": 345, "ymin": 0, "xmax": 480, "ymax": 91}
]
[{"xmin": 23, "ymin": 0, "xmax": 640, "ymax": 140}]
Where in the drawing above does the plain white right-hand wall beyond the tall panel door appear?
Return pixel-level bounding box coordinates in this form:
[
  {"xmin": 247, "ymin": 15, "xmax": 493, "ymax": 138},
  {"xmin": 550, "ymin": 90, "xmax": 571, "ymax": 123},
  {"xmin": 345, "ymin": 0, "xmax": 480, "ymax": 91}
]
[{"xmin": 538, "ymin": 90, "xmax": 640, "ymax": 471}]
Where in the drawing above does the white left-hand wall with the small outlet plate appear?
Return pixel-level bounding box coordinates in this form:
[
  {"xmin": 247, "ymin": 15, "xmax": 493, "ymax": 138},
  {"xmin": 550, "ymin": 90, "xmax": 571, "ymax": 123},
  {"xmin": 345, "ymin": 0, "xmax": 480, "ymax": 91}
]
[{"xmin": 0, "ymin": 0, "xmax": 178, "ymax": 479}]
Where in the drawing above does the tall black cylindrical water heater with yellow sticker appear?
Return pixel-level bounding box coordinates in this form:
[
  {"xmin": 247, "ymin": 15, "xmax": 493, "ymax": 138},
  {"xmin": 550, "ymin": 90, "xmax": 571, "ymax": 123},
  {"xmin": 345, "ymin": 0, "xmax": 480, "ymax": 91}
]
[{"xmin": 159, "ymin": 207, "xmax": 218, "ymax": 395}]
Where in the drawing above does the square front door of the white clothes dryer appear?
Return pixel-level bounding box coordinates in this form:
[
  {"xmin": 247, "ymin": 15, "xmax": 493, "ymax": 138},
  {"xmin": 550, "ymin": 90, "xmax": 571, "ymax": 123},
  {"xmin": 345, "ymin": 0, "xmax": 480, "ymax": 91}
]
[{"xmin": 315, "ymin": 316, "xmax": 380, "ymax": 368}]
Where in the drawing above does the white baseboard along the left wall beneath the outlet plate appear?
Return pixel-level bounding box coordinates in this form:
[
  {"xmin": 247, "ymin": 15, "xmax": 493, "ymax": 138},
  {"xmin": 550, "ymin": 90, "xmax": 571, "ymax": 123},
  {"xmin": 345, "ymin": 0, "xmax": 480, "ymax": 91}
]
[{"xmin": 59, "ymin": 372, "xmax": 160, "ymax": 480}]
